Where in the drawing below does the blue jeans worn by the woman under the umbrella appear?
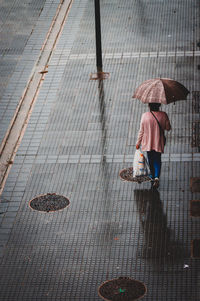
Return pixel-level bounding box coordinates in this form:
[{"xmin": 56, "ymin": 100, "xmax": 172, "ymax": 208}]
[{"xmin": 147, "ymin": 150, "xmax": 161, "ymax": 179}]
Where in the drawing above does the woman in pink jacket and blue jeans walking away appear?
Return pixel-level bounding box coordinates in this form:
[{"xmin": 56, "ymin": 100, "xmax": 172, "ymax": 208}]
[{"xmin": 136, "ymin": 103, "xmax": 171, "ymax": 188}]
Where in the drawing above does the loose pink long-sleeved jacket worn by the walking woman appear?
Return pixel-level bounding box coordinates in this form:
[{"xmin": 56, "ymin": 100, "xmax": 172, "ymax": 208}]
[{"xmin": 136, "ymin": 111, "xmax": 171, "ymax": 153}]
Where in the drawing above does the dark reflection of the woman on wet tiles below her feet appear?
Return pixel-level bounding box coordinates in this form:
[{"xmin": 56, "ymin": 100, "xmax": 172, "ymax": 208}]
[{"xmin": 134, "ymin": 189, "xmax": 188, "ymax": 263}]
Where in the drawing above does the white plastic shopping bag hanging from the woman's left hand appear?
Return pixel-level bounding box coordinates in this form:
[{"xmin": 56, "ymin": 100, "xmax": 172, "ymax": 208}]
[{"xmin": 133, "ymin": 149, "xmax": 148, "ymax": 177}]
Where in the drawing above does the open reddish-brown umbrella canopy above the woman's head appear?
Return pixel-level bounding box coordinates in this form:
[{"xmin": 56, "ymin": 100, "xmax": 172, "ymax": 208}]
[{"xmin": 133, "ymin": 78, "xmax": 190, "ymax": 104}]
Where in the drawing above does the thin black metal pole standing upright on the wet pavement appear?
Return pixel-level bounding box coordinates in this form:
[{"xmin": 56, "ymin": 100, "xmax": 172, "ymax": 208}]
[{"xmin": 94, "ymin": 0, "xmax": 103, "ymax": 72}]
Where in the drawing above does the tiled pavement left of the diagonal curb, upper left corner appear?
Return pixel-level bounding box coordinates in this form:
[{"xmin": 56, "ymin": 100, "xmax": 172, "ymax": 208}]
[{"xmin": 0, "ymin": 0, "xmax": 60, "ymax": 143}]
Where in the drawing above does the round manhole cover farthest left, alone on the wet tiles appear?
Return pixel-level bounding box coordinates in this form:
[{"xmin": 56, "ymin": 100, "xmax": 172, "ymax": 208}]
[{"xmin": 29, "ymin": 193, "xmax": 69, "ymax": 212}]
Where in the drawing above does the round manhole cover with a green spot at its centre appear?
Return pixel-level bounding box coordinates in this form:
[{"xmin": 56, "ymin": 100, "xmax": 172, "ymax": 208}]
[{"xmin": 98, "ymin": 277, "xmax": 147, "ymax": 301}]
